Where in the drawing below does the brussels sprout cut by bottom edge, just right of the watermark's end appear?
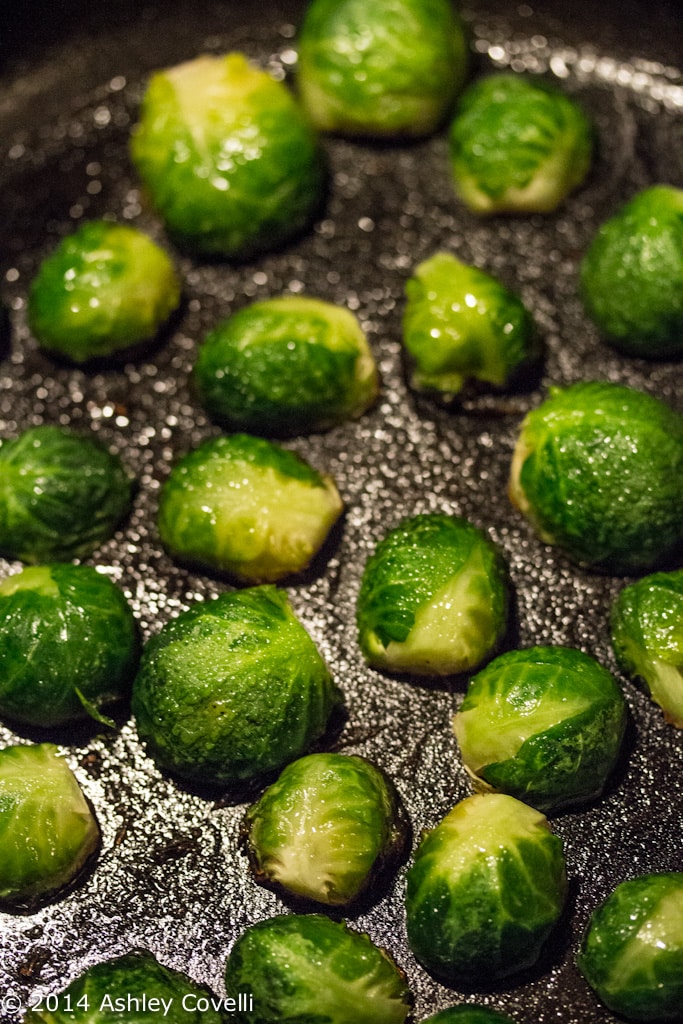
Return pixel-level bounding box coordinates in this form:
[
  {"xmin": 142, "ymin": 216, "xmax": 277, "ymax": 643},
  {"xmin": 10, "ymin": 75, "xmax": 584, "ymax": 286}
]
[{"xmin": 225, "ymin": 914, "xmax": 412, "ymax": 1024}]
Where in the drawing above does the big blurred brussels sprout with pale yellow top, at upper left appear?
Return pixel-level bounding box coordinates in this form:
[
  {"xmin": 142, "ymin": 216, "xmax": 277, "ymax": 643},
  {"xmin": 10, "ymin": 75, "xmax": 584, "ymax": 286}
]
[{"xmin": 131, "ymin": 53, "xmax": 324, "ymax": 258}]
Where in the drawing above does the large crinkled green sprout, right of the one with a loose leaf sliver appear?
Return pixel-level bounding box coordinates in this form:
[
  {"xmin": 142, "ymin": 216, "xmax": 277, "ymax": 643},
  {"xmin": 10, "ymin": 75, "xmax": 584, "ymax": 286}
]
[{"xmin": 132, "ymin": 586, "xmax": 341, "ymax": 785}]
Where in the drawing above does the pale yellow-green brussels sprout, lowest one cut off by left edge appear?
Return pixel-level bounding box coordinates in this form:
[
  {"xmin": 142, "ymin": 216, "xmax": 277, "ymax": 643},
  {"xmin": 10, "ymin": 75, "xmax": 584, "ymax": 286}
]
[{"xmin": 0, "ymin": 743, "xmax": 99, "ymax": 910}]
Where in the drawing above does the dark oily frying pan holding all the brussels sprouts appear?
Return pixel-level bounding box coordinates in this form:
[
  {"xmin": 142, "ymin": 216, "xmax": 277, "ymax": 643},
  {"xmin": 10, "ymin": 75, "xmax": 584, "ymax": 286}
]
[{"xmin": 0, "ymin": 0, "xmax": 683, "ymax": 1024}]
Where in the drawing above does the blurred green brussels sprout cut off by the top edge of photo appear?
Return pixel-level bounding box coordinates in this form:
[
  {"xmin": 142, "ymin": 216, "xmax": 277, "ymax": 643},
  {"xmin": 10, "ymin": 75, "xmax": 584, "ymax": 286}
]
[{"xmin": 298, "ymin": 0, "xmax": 468, "ymax": 137}]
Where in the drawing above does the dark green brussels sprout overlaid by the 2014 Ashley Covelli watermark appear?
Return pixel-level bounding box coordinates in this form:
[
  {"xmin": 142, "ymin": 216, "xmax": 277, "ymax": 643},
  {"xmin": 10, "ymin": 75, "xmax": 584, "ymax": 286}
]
[{"xmin": 24, "ymin": 949, "xmax": 226, "ymax": 1024}]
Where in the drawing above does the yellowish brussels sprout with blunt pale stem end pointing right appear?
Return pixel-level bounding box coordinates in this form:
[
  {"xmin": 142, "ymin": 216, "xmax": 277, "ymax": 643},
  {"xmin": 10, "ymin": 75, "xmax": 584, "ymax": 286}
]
[{"xmin": 159, "ymin": 434, "xmax": 342, "ymax": 583}]
